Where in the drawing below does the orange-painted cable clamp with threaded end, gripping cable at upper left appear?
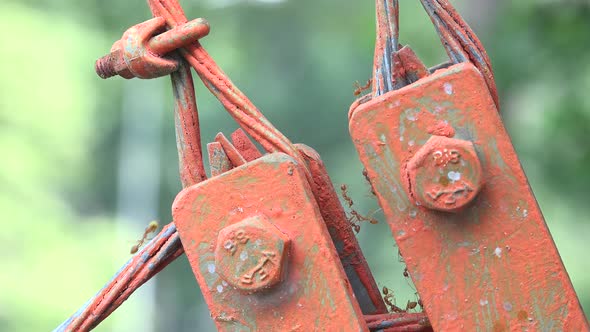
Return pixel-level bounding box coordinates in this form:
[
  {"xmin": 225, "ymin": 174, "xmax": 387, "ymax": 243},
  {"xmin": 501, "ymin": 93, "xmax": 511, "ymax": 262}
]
[{"xmin": 95, "ymin": 17, "xmax": 209, "ymax": 79}]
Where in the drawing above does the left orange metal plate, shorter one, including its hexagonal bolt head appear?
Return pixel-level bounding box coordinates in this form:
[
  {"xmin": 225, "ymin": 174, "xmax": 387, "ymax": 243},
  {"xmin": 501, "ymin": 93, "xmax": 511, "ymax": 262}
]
[{"xmin": 173, "ymin": 153, "xmax": 367, "ymax": 331}]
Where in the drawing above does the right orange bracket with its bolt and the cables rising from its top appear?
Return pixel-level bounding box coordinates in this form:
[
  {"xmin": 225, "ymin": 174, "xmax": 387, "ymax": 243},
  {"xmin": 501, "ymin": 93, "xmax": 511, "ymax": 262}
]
[{"xmin": 349, "ymin": 0, "xmax": 589, "ymax": 331}]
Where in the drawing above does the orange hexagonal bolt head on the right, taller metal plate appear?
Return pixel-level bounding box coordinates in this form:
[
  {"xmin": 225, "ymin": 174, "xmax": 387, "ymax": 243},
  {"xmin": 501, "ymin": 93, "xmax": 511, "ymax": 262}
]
[{"xmin": 407, "ymin": 136, "xmax": 483, "ymax": 212}]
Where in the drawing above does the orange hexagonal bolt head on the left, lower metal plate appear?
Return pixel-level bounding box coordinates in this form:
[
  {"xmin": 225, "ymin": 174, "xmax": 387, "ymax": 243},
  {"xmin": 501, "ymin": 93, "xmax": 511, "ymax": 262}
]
[{"xmin": 215, "ymin": 216, "xmax": 291, "ymax": 293}]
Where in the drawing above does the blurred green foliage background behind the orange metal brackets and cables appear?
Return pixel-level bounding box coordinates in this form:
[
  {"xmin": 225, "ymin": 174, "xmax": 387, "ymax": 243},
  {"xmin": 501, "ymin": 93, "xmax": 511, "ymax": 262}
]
[{"xmin": 0, "ymin": 0, "xmax": 590, "ymax": 332}]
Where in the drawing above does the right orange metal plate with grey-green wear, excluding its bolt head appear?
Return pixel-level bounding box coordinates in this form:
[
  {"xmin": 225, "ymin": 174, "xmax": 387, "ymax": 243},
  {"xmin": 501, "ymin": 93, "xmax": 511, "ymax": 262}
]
[{"xmin": 350, "ymin": 63, "xmax": 588, "ymax": 331}]
